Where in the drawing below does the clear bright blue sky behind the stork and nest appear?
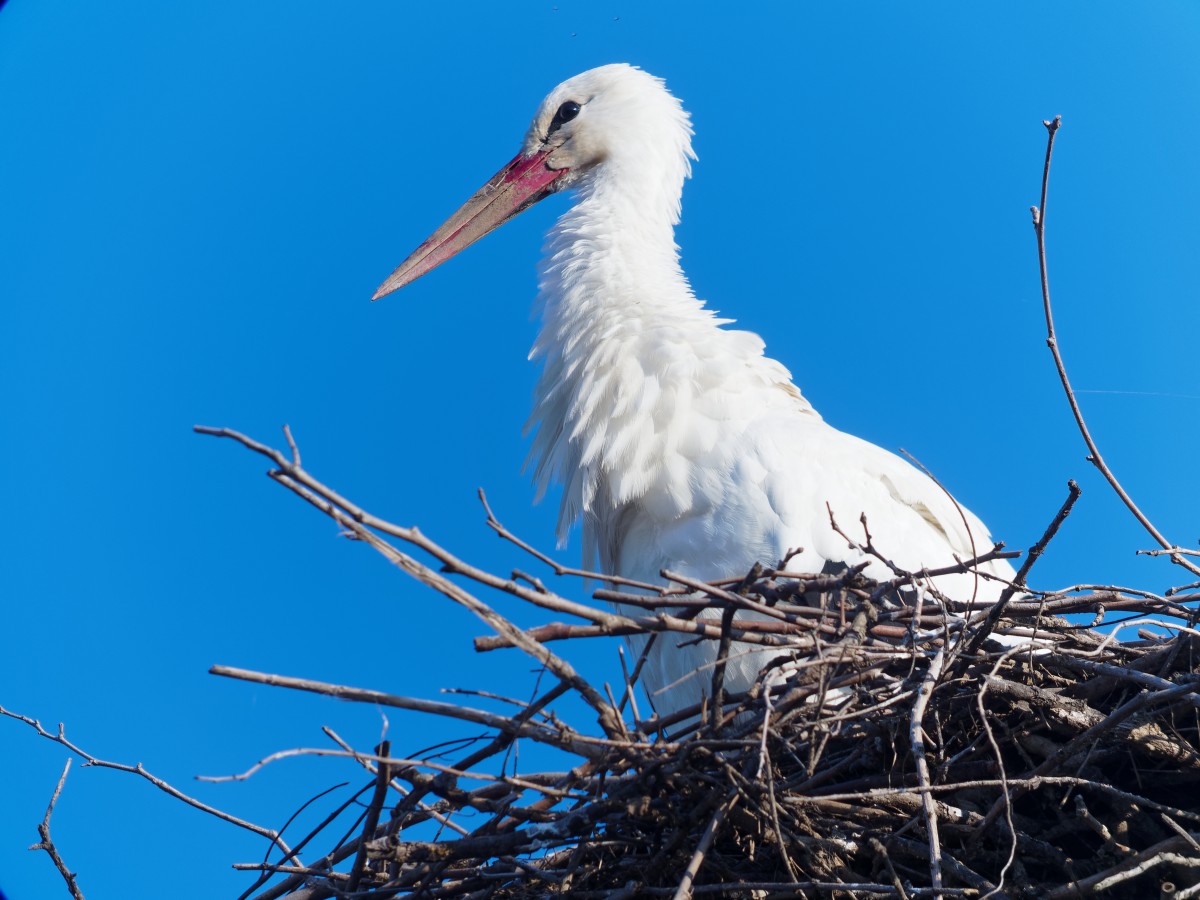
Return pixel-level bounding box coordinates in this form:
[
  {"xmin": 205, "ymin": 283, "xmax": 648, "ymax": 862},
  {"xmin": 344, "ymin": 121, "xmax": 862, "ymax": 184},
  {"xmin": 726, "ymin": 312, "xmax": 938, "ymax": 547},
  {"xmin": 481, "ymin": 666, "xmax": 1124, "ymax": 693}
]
[{"xmin": 0, "ymin": 0, "xmax": 1200, "ymax": 900}]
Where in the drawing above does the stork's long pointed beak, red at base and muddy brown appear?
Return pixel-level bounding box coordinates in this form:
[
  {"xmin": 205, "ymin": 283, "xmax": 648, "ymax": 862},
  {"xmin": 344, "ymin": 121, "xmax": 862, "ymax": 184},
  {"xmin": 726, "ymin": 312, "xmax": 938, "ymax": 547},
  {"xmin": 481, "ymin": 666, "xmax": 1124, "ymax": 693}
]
[{"xmin": 371, "ymin": 150, "xmax": 570, "ymax": 300}]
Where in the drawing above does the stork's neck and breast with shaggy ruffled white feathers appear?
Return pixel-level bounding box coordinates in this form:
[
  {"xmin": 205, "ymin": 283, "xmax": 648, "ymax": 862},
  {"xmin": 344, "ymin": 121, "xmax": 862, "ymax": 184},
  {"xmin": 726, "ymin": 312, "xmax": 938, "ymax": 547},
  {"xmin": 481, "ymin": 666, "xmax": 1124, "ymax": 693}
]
[{"xmin": 529, "ymin": 160, "xmax": 811, "ymax": 549}]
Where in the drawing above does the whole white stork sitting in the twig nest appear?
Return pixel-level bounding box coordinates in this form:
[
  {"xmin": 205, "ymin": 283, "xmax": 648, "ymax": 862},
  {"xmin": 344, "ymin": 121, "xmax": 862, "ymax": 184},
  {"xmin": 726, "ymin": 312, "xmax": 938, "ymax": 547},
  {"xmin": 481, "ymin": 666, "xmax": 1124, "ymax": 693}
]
[{"xmin": 376, "ymin": 65, "xmax": 1014, "ymax": 715}]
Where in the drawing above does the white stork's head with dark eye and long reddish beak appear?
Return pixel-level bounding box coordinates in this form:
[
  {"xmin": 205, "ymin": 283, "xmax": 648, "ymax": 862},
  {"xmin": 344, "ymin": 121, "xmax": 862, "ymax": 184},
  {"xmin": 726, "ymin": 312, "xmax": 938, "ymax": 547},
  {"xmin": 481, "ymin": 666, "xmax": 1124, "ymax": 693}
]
[{"xmin": 372, "ymin": 64, "xmax": 695, "ymax": 300}]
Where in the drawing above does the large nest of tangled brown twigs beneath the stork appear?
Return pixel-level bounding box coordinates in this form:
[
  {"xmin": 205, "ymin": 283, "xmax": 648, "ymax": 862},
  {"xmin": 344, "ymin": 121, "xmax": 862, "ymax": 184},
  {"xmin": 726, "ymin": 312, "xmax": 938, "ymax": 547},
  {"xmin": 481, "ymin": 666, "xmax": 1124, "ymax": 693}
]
[{"xmin": 182, "ymin": 430, "xmax": 1200, "ymax": 900}]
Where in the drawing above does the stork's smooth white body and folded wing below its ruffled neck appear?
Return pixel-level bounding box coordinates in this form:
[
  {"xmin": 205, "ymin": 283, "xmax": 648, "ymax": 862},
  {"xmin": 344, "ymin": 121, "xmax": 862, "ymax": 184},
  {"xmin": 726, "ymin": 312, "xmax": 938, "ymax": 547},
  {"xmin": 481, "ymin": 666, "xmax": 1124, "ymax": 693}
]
[{"xmin": 619, "ymin": 415, "xmax": 1013, "ymax": 602}]
